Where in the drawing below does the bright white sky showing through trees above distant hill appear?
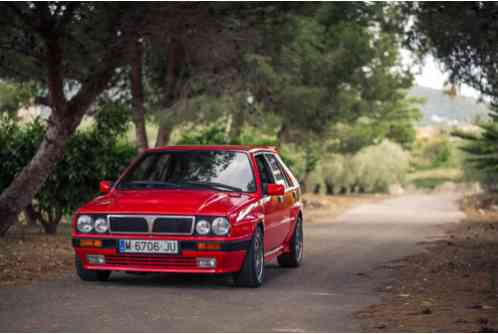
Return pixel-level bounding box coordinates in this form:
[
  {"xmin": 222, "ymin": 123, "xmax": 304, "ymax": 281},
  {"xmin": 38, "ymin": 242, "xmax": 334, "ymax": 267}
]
[{"xmin": 401, "ymin": 50, "xmax": 479, "ymax": 98}]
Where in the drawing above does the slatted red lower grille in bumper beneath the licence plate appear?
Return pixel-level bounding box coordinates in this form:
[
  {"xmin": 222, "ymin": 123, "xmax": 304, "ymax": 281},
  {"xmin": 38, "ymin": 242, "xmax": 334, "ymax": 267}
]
[{"xmin": 105, "ymin": 255, "xmax": 197, "ymax": 268}]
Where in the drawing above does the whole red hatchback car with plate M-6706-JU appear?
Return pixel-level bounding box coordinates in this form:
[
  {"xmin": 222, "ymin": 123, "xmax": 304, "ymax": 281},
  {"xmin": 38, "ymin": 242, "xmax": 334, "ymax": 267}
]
[{"xmin": 72, "ymin": 145, "xmax": 303, "ymax": 287}]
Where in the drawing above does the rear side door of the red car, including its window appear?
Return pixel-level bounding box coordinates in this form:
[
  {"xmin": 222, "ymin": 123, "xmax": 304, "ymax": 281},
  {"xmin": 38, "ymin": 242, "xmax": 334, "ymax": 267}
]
[{"xmin": 265, "ymin": 153, "xmax": 294, "ymax": 248}]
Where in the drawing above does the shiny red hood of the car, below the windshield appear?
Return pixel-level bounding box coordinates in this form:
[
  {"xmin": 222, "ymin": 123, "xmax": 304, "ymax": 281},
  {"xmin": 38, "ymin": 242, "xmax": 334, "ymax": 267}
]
[{"xmin": 79, "ymin": 189, "xmax": 255, "ymax": 215}]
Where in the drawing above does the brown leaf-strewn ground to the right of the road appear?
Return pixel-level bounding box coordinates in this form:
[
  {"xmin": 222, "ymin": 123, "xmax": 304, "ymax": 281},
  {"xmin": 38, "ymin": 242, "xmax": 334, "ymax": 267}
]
[{"xmin": 356, "ymin": 196, "xmax": 498, "ymax": 332}]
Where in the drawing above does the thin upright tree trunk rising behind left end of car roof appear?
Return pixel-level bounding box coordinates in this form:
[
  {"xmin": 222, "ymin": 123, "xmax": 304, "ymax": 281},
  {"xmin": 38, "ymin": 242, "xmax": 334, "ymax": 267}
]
[{"xmin": 131, "ymin": 41, "xmax": 149, "ymax": 151}]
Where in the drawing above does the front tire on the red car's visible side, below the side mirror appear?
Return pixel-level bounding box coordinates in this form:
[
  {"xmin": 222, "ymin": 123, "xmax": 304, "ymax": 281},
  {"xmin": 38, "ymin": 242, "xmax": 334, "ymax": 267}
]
[{"xmin": 233, "ymin": 227, "xmax": 265, "ymax": 288}]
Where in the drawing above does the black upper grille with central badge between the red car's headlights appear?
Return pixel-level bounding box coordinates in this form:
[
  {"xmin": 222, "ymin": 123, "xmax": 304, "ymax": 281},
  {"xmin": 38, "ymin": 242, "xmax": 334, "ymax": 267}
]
[{"xmin": 109, "ymin": 215, "xmax": 194, "ymax": 235}]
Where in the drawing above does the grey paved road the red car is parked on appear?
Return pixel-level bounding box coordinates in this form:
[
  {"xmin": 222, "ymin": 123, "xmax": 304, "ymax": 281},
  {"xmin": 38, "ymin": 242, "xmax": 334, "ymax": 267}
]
[{"xmin": 0, "ymin": 194, "xmax": 463, "ymax": 332}]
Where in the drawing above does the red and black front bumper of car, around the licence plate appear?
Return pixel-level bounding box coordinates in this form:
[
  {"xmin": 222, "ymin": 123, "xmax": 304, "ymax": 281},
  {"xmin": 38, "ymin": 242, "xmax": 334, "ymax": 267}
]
[{"xmin": 73, "ymin": 237, "xmax": 250, "ymax": 274}]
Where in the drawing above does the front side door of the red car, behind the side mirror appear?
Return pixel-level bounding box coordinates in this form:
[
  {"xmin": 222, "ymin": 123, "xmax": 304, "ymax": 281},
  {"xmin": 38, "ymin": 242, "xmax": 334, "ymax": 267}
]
[{"xmin": 254, "ymin": 153, "xmax": 281, "ymax": 253}]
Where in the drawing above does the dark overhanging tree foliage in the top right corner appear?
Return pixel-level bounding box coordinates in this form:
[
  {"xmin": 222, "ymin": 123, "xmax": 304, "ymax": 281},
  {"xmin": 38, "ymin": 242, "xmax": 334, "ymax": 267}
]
[{"xmin": 404, "ymin": 1, "xmax": 498, "ymax": 103}]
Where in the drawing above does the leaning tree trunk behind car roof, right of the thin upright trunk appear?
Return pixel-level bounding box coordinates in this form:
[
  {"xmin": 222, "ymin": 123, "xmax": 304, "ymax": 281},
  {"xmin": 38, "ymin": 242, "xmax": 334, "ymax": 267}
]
[{"xmin": 156, "ymin": 39, "xmax": 185, "ymax": 147}]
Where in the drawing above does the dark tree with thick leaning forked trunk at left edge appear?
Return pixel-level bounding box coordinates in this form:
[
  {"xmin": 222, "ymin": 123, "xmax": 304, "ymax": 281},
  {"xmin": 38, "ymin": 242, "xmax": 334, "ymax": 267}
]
[{"xmin": 0, "ymin": 2, "xmax": 150, "ymax": 235}]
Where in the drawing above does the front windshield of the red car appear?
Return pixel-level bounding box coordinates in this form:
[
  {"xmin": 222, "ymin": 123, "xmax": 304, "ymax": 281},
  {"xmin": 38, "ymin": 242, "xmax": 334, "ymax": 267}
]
[{"xmin": 117, "ymin": 151, "xmax": 256, "ymax": 192}]
